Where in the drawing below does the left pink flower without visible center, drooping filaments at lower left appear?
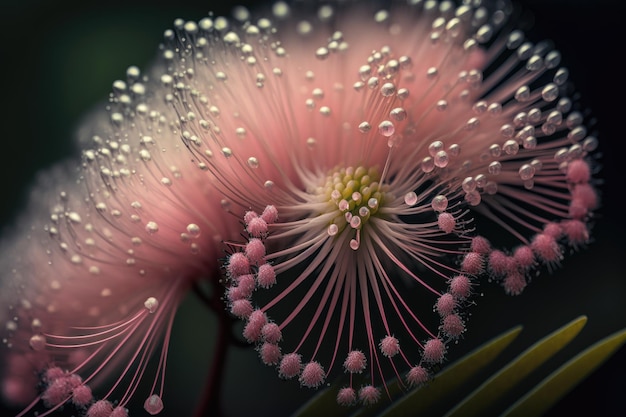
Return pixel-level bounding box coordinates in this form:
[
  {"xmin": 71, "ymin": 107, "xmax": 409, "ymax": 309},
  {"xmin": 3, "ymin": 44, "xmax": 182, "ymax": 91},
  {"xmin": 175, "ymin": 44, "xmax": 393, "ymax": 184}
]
[{"xmin": 0, "ymin": 22, "xmax": 239, "ymax": 416}]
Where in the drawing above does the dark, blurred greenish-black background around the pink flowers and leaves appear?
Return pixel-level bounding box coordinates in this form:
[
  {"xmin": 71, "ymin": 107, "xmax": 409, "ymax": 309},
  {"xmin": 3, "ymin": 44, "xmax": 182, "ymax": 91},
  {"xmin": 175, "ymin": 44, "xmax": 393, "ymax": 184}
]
[{"xmin": 0, "ymin": 0, "xmax": 626, "ymax": 417}]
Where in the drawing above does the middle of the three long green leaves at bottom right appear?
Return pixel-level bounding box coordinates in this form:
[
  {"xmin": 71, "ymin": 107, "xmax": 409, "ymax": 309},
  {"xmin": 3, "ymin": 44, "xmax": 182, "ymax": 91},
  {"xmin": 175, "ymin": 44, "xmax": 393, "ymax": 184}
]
[{"xmin": 446, "ymin": 316, "xmax": 587, "ymax": 417}]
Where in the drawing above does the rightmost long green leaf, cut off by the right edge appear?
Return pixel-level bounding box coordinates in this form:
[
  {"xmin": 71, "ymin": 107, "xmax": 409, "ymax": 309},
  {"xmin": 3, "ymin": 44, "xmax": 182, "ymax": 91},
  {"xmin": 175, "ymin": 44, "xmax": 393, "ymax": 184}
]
[{"xmin": 504, "ymin": 329, "xmax": 626, "ymax": 417}]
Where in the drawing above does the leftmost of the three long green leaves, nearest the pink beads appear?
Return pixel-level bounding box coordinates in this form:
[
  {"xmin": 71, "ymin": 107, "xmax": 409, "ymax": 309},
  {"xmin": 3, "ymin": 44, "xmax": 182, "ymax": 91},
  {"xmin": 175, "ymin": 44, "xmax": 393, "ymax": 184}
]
[{"xmin": 376, "ymin": 326, "xmax": 522, "ymax": 417}]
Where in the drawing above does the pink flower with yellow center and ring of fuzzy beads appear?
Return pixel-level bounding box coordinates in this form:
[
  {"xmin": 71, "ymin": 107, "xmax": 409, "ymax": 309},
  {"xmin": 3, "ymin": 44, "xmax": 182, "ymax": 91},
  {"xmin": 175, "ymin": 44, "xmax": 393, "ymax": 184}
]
[{"xmin": 191, "ymin": 2, "xmax": 597, "ymax": 405}]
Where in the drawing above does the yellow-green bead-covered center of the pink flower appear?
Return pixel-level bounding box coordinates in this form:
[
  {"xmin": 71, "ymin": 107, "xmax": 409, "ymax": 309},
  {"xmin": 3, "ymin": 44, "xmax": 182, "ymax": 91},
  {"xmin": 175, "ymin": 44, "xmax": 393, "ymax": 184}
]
[{"xmin": 317, "ymin": 165, "xmax": 387, "ymax": 250}]
